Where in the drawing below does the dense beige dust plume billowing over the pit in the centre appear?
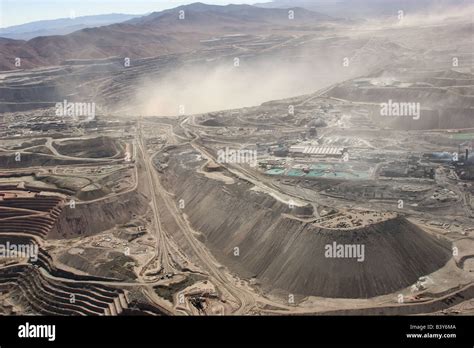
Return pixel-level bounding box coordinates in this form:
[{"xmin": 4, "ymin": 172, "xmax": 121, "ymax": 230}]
[{"xmin": 134, "ymin": 58, "xmax": 356, "ymax": 116}]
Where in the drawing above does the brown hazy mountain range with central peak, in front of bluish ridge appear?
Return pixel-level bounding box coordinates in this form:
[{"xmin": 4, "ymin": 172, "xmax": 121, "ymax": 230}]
[{"xmin": 0, "ymin": 3, "xmax": 332, "ymax": 70}]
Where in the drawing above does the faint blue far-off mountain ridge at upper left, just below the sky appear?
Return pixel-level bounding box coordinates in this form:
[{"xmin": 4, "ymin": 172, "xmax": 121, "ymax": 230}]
[{"xmin": 0, "ymin": 13, "xmax": 140, "ymax": 40}]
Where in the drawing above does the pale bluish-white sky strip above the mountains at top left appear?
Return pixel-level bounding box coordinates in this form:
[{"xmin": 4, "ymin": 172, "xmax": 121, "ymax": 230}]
[{"xmin": 0, "ymin": 0, "xmax": 260, "ymax": 28}]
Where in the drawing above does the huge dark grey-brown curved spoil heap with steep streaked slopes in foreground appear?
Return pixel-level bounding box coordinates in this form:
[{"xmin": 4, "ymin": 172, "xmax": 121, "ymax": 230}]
[{"xmin": 165, "ymin": 148, "xmax": 451, "ymax": 298}]
